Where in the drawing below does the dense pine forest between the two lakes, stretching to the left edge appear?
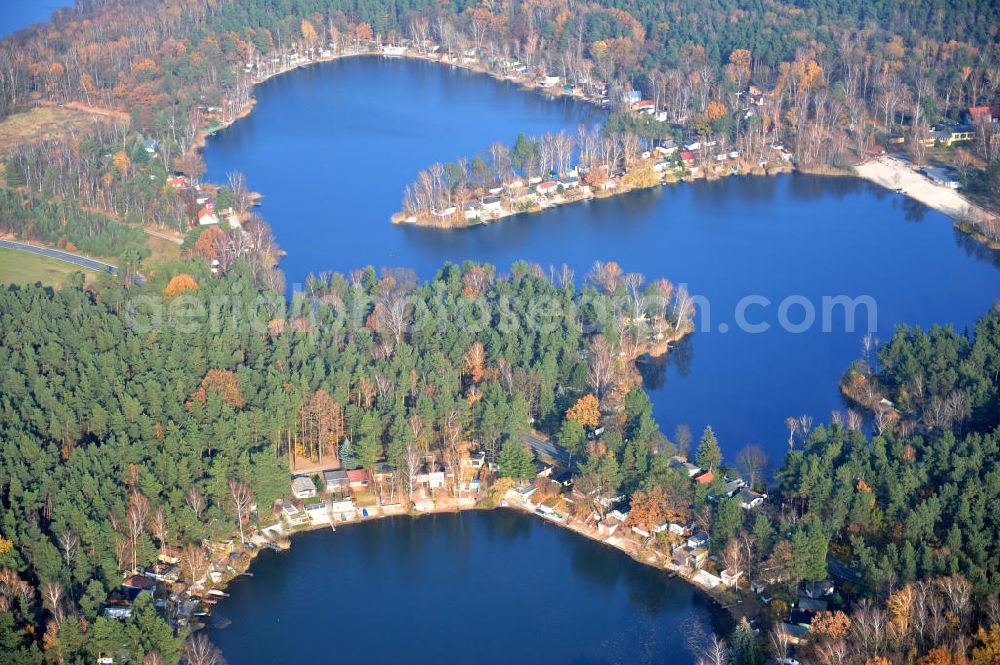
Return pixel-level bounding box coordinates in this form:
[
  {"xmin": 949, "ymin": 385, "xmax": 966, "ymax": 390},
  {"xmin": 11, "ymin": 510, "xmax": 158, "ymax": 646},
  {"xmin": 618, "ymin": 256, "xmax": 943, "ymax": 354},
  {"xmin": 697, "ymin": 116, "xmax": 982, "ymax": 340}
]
[{"xmin": 0, "ymin": 258, "xmax": 686, "ymax": 662}]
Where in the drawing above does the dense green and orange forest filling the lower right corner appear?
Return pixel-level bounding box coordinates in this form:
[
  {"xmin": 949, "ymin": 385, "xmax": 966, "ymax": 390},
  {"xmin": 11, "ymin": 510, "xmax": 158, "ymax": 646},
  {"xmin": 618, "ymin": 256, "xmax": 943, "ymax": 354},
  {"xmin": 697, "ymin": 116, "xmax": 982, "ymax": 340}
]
[{"xmin": 727, "ymin": 308, "xmax": 1000, "ymax": 665}]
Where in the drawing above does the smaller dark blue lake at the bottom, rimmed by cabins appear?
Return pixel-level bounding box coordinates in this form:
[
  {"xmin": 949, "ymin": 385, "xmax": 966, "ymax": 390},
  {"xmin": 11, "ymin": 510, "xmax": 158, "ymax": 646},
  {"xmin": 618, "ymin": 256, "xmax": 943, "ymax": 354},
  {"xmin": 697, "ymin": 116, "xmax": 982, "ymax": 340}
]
[{"xmin": 209, "ymin": 510, "xmax": 730, "ymax": 665}]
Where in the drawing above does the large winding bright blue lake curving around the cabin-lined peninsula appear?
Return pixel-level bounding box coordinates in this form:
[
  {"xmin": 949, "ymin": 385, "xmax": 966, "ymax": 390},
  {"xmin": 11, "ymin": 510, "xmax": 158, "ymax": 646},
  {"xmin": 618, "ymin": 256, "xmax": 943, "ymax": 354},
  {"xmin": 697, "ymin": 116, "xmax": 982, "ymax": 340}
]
[{"xmin": 205, "ymin": 58, "xmax": 1000, "ymax": 464}]
